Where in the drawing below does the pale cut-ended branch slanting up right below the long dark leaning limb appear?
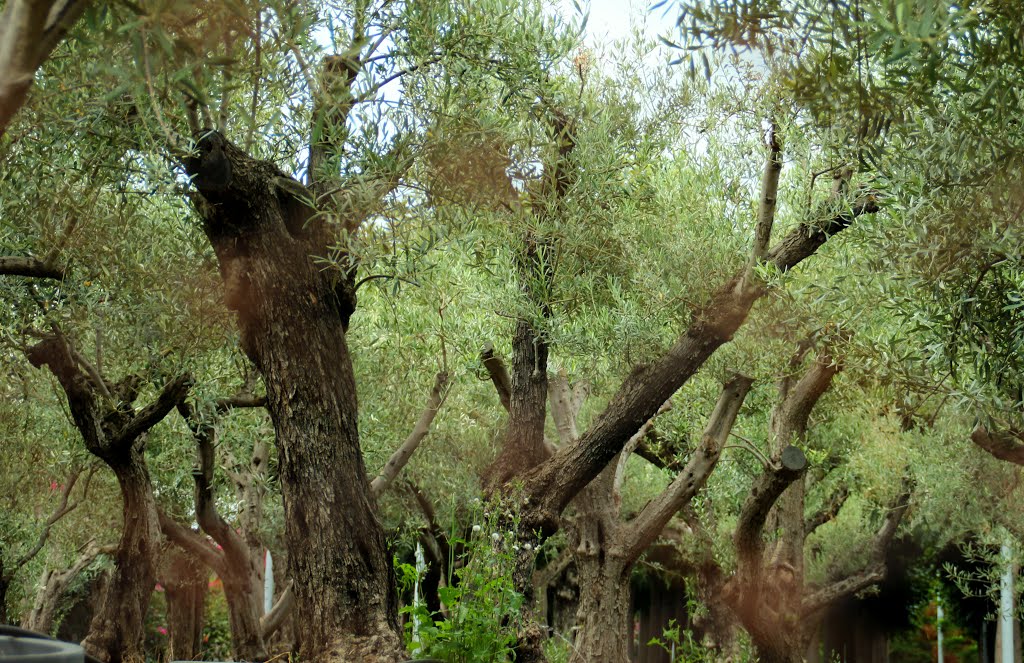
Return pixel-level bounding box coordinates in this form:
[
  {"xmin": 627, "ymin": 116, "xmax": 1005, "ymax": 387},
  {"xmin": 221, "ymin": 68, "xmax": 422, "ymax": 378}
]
[{"xmin": 625, "ymin": 375, "xmax": 754, "ymax": 562}]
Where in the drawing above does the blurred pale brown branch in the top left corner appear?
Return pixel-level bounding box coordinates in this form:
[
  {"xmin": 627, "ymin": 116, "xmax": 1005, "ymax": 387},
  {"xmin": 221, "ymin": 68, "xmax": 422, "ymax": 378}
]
[{"xmin": 0, "ymin": 0, "xmax": 89, "ymax": 138}]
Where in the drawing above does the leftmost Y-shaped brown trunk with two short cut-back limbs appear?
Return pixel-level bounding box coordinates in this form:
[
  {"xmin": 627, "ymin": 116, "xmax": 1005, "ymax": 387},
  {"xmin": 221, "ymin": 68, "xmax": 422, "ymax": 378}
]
[{"xmin": 28, "ymin": 334, "xmax": 190, "ymax": 663}]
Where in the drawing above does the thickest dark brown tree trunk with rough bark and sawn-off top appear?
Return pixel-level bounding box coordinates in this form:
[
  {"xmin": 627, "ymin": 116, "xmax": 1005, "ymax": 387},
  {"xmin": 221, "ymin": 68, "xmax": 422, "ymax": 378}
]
[{"xmin": 187, "ymin": 132, "xmax": 402, "ymax": 661}]
